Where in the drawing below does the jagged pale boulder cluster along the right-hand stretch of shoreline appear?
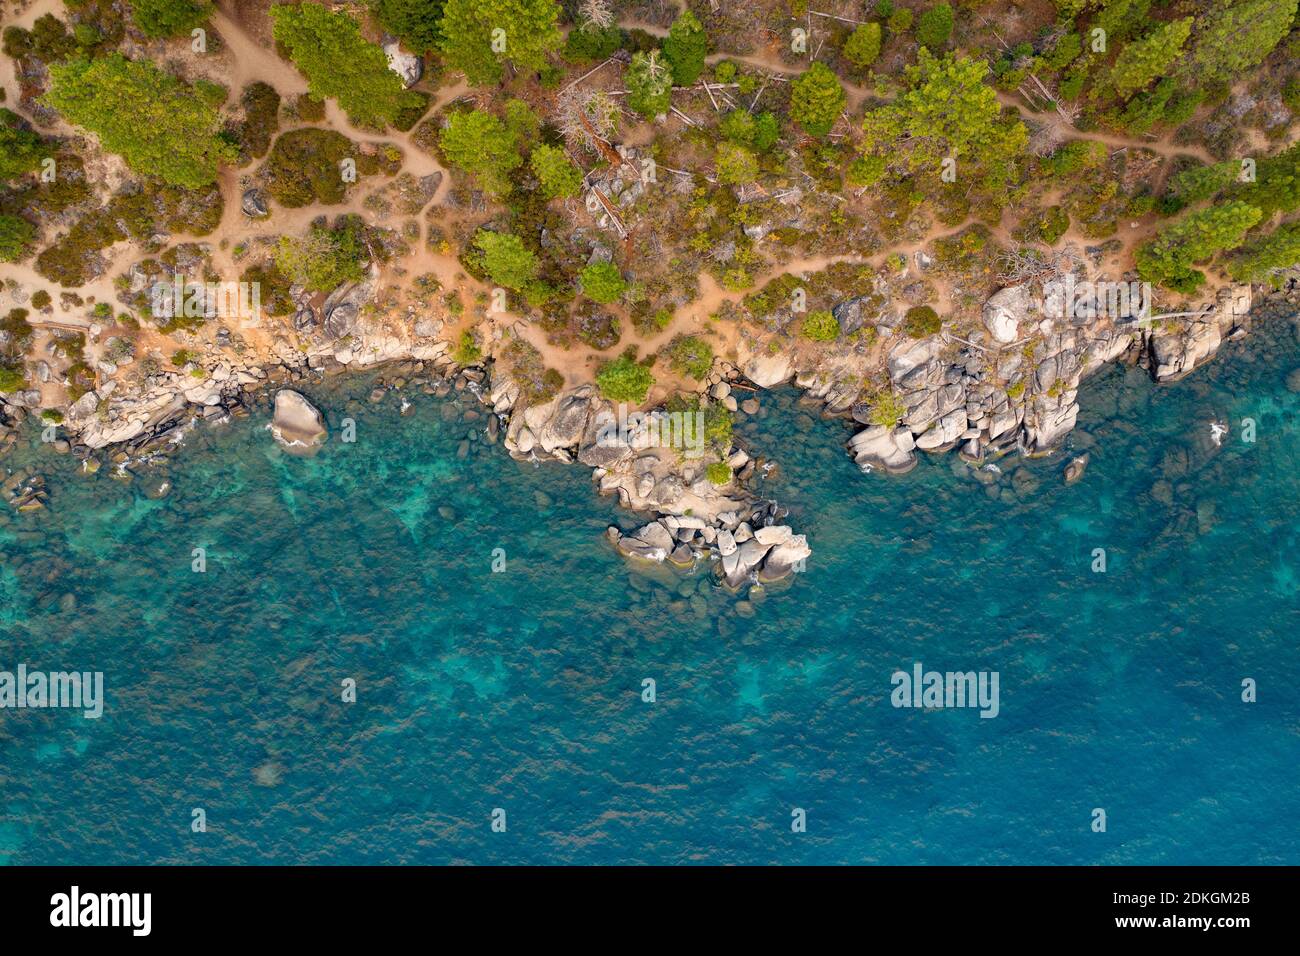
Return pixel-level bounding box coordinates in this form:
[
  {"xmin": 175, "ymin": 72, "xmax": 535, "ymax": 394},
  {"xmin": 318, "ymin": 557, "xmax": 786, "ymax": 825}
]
[{"xmin": 744, "ymin": 269, "xmax": 1251, "ymax": 473}]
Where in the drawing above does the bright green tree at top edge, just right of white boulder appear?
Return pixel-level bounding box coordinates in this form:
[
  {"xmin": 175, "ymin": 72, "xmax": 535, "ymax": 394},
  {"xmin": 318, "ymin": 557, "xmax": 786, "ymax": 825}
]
[{"xmin": 442, "ymin": 0, "xmax": 563, "ymax": 86}]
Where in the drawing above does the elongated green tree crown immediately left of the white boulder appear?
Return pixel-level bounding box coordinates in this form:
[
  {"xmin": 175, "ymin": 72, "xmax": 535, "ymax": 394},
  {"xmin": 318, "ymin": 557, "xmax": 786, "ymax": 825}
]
[{"xmin": 270, "ymin": 3, "xmax": 417, "ymax": 127}]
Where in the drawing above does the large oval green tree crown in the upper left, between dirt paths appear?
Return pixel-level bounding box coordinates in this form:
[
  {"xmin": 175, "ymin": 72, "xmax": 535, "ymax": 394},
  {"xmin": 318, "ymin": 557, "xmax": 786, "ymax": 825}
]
[{"xmin": 46, "ymin": 53, "xmax": 237, "ymax": 189}]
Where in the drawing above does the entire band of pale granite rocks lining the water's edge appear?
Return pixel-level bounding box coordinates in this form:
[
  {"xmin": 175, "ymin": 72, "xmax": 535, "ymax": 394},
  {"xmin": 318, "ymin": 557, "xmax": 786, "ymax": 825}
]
[{"xmin": 0, "ymin": 273, "xmax": 1300, "ymax": 589}]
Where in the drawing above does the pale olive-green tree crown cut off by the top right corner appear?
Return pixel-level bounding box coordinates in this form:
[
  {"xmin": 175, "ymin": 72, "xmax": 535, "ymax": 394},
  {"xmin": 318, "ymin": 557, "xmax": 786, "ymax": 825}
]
[{"xmin": 1187, "ymin": 0, "xmax": 1297, "ymax": 83}]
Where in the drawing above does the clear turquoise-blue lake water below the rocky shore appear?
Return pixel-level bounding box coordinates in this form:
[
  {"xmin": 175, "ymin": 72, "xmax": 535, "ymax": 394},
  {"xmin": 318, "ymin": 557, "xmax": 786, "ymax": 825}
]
[{"xmin": 0, "ymin": 323, "xmax": 1300, "ymax": 864}]
